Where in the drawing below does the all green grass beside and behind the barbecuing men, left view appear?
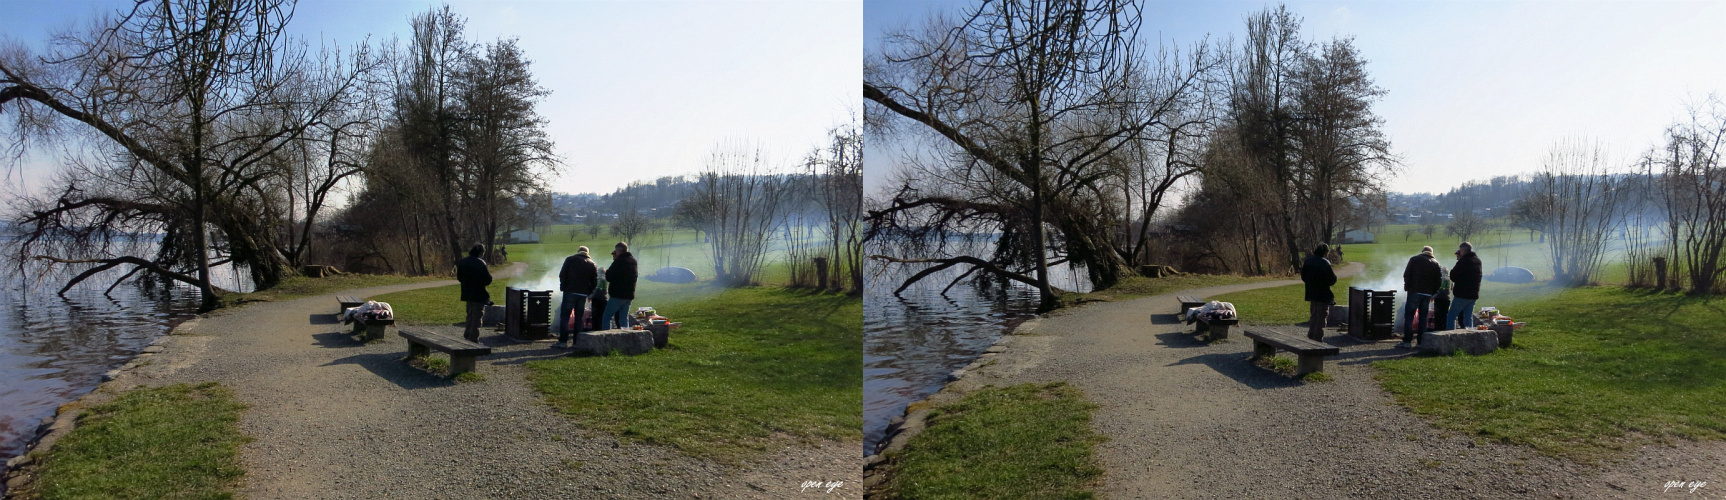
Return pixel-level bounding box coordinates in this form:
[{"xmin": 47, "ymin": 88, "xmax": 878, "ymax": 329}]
[{"xmin": 376, "ymin": 226, "xmax": 863, "ymax": 462}]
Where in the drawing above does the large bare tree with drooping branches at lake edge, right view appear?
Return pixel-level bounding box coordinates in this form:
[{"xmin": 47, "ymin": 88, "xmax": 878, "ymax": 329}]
[{"xmin": 863, "ymin": 0, "xmax": 1213, "ymax": 310}]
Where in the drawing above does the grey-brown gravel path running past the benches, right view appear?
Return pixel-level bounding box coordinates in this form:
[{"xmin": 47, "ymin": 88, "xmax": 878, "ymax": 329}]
[{"xmin": 965, "ymin": 267, "xmax": 1726, "ymax": 498}]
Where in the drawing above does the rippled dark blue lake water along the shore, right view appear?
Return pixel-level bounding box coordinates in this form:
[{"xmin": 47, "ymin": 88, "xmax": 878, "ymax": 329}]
[{"xmin": 863, "ymin": 250, "xmax": 1087, "ymax": 453}]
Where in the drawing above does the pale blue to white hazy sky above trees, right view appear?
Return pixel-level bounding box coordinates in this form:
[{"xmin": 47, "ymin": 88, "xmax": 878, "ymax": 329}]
[{"xmin": 863, "ymin": 0, "xmax": 1726, "ymax": 193}]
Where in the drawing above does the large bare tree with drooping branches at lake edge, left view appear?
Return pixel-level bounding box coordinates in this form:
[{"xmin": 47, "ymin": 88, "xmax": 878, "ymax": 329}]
[{"xmin": 0, "ymin": 0, "xmax": 376, "ymax": 310}]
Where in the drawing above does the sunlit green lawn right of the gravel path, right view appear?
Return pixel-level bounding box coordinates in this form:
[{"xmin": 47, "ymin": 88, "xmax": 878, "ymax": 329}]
[{"xmin": 1374, "ymin": 286, "xmax": 1726, "ymax": 460}]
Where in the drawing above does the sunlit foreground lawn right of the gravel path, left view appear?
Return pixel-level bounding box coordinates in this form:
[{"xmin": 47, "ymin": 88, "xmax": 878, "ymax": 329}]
[{"xmin": 528, "ymin": 286, "xmax": 863, "ymax": 462}]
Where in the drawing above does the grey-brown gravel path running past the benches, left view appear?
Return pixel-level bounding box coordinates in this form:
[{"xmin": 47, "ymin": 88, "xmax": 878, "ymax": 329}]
[{"xmin": 106, "ymin": 265, "xmax": 861, "ymax": 498}]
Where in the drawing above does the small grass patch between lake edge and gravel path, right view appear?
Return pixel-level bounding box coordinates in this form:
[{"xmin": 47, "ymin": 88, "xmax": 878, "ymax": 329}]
[{"xmin": 880, "ymin": 383, "xmax": 1103, "ymax": 498}]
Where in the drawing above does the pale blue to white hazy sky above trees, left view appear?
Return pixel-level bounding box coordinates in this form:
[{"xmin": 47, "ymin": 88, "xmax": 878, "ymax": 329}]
[{"xmin": 0, "ymin": 0, "xmax": 863, "ymax": 193}]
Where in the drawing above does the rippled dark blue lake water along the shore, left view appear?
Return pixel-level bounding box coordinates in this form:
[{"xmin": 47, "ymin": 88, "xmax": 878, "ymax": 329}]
[{"xmin": 0, "ymin": 267, "xmax": 249, "ymax": 464}]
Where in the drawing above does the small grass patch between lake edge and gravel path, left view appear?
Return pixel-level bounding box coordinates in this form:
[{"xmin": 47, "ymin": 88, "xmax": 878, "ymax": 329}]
[{"xmin": 28, "ymin": 383, "xmax": 249, "ymax": 498}]
